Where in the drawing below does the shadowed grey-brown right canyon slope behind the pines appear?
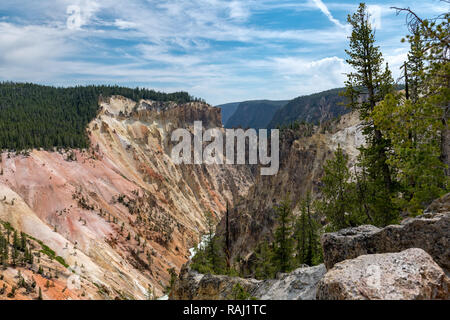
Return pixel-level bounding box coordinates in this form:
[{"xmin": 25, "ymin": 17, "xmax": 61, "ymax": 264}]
[{"xmin": 217, "ymin": 113, "xmax": 364, "ymax": 273}]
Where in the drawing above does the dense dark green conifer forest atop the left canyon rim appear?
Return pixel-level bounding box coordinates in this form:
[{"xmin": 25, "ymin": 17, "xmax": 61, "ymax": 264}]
[{"xmin": 0, "ymin": 82, "xmax": 197, "ymax": 150}]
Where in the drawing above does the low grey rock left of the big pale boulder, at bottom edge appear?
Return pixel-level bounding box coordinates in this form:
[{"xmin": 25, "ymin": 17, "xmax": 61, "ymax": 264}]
[{"xmin": 170, "ymin": 264, "xmax": 326, "ymax": 300}]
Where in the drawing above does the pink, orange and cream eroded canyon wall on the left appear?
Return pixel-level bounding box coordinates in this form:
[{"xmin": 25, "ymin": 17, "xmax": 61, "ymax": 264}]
[{"xmin": 0, "ymin": 96, "xmax": 253, "ymax": 299}]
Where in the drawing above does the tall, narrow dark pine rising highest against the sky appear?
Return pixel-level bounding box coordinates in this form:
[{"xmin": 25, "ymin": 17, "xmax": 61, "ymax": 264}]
[{"xmin": 345, "ymin": 3, "xmax": 398, "ymax": 225}]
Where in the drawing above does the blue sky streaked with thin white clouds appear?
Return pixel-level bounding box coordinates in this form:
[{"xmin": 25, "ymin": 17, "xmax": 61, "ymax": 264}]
[{"xmin": 0, "ymin": 0, "xmax": 449, "ymax": 105}]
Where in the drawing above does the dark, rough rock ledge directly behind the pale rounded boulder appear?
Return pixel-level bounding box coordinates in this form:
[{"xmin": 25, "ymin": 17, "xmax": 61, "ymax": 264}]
[{"xmin": 321, "ymin": 212, "xmax": 450, "ymax": 272}]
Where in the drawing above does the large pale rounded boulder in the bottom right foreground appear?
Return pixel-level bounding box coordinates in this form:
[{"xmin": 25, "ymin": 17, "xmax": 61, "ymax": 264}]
[{"xmin": 317, "ymin": 248, "xmax": 450, "ymax": 300}]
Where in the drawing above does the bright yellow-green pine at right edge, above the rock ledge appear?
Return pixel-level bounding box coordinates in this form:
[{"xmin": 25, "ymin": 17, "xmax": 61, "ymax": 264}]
[{"xmin": 374, "ymin": 9, "xmax": 450, "ymax": 215}]
